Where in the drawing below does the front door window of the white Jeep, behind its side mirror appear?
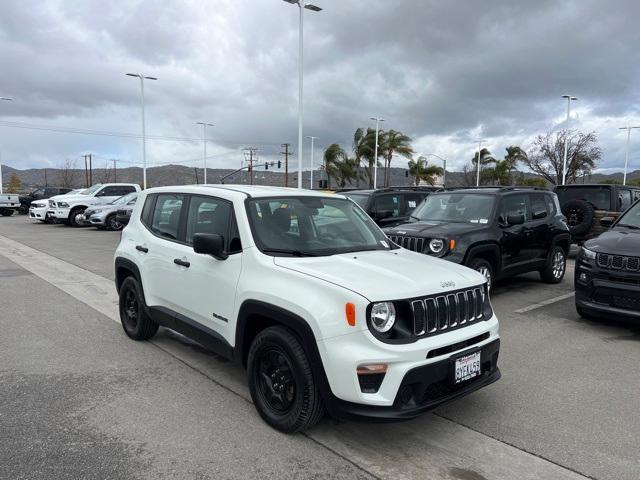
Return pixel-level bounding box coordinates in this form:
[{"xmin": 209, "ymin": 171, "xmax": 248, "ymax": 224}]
[{"xmin": 186, "ymin": 196, "xmax": 231, "ymax": 248}]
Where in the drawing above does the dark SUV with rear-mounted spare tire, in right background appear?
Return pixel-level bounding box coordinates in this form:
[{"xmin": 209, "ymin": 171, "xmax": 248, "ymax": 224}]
[{"xmin": 554, "ymin": 184, "xmax": 640, "ymax": 244}]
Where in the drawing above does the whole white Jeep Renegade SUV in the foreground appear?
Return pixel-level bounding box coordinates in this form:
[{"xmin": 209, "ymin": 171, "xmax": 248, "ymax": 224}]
[{"xmin": 115, "ymin": 185, "xmax": 500, "ymax": 432}]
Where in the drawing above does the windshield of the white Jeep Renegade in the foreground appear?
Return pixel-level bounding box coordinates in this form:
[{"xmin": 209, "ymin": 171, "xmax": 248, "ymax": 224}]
[{"xmin": 247, "ymin": 196, "xmax": 392, "ymax": 256}]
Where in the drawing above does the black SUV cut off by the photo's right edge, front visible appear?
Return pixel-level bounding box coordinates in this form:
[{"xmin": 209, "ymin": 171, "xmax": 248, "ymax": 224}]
[{"xmin": 575, "ymin": 197, "xmax": 640, "ymax": 320}]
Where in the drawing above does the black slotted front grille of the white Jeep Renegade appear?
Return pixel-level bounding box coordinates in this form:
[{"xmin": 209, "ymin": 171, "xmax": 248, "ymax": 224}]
[{"xmin": 411, "ymin": 287, "xmax": 486, "ymax": 337}]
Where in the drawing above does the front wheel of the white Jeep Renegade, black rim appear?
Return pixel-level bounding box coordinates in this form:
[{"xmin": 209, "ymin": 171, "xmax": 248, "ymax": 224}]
[{"xmin": 247, "ymin": 326, "xmax": 324, "ymax": 433}]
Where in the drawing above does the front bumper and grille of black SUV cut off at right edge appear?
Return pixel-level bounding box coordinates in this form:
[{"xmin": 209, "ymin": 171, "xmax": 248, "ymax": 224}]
[{"xmin": 574, "ymin": 258, "xmax": 640, "ymax": 320}]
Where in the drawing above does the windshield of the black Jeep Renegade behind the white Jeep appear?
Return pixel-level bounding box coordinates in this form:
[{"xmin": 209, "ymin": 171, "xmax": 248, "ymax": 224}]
[{"xmin": 411, "ymin": 193, "xmax": 495, "ymax": 223}]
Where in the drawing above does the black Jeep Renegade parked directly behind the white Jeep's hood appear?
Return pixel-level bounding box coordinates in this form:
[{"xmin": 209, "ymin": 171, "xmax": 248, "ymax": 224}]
[{"xmin": 385, "ymin": 187, "xmax": 570, "ymax": 286}]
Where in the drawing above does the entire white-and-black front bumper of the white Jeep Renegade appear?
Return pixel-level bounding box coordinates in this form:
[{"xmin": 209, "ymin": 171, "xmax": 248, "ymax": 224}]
[{"xmin": 318, "ymin": 315, "xmax": 500, "ymax": 418}]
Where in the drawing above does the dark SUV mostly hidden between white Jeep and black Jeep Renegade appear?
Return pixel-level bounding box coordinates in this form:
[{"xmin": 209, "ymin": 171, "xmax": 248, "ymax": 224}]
[{"xmin": 336, "ymin": 187, "xmax": 438, "ymax": 228}]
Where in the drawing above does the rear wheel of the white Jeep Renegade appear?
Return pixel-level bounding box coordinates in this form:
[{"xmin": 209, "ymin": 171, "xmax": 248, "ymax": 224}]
[{"xmin": 119, "ymin": 277, "xmax": 159, "ymax": 341}]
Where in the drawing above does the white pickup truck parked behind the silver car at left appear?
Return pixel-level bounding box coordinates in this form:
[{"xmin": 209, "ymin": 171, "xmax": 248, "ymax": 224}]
[{"xmin": 47, "ymin": 183, "xmax": 140, "ymax": 227}]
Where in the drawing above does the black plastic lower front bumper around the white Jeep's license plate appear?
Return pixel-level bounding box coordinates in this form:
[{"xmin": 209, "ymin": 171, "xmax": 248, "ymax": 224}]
[{"xmin": 327, "ymin": 339, "xmax": 502, "ymax": 421}]
